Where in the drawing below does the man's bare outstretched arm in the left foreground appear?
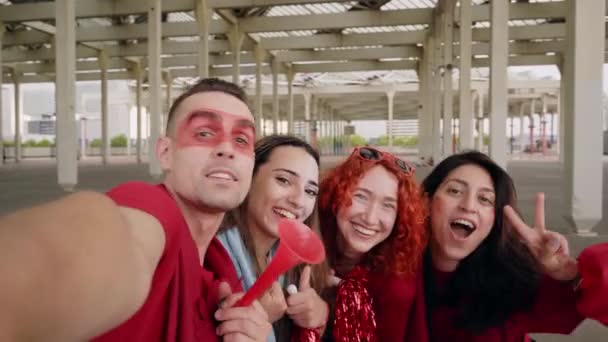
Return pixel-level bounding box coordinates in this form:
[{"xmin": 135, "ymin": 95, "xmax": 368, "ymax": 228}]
[{"xmin": 0, "ymin": 192, "xmax": 165, "ymax": 341}]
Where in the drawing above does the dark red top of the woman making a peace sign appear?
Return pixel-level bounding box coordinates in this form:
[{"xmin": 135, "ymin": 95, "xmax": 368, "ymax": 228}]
[{"xmin": 426, "ymin": 244, "xmax": 608, "ymax": 342}]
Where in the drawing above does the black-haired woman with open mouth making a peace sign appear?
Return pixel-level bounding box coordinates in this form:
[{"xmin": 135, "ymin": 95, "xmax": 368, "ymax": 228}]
[{"xmin": 422, "ymin": 151, "xmax": 608, "ymax": 342}]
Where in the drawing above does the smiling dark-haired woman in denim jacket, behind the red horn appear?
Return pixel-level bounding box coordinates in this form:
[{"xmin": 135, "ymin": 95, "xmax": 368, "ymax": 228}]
[{"xmin": 218, "ymin": 135, "xmax": 329, "ymax": 341}]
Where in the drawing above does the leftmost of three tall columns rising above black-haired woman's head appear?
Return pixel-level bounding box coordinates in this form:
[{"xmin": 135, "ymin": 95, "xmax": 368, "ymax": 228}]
[{"xmin": 442, "ymin": 0, "xmax": 455, "ymax": 157}]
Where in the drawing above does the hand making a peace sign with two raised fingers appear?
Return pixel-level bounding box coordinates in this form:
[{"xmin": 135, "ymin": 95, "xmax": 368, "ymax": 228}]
[{"xmin": 504, "ymin": 193, "xmax": 578, "ymax": 281}]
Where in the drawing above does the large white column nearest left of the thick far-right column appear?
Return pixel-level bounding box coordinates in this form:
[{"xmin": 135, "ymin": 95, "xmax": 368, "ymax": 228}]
[{"xmin": 490, "ymin": 1, "xmax": 509, "ymax": 169}]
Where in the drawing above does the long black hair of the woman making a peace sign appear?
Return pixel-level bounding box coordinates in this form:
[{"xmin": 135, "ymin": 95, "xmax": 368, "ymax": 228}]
[{"xmin": 422, "ymin": 151, "xmax": 540, "ymax": 332}]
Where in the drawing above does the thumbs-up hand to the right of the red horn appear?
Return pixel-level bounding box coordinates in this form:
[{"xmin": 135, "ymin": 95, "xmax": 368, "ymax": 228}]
[{"xmin": 287, "ymin": 265, "xmax": 329, "ymax": 329}]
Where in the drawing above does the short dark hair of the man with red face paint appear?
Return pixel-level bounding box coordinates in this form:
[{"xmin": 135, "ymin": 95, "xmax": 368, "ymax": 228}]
[{"xmin": 166, "ymin": 78, "xmax": 248, "ymax": 135}]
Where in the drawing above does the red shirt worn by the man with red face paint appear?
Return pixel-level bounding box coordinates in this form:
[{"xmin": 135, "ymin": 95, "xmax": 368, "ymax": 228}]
[{"xmin": 94, "ymin": 182, "xmax": 242, "ymax": 342}]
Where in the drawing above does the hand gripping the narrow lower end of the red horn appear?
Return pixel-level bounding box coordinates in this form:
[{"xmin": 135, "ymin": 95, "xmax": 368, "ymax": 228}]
[{"xmin": 215, "ymin": 282, "xmax": 272, "ymax": 342}]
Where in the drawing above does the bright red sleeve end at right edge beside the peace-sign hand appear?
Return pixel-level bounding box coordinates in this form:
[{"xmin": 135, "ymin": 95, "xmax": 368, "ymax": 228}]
[{"xmin": 576, "ymin": 243, "xmax": 608, "ymax": 325}]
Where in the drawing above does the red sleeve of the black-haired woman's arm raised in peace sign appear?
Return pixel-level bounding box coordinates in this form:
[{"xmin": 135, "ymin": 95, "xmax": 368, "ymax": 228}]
[{"xmin": 509, "ymin": 244, "xmax": 608, "ymax": 334}]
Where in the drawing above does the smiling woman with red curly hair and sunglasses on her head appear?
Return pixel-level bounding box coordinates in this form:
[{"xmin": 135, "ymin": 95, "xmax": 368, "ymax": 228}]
[{"xmin": 319, "ymin": 147, "xmax": 427, "ymax": 342}]
